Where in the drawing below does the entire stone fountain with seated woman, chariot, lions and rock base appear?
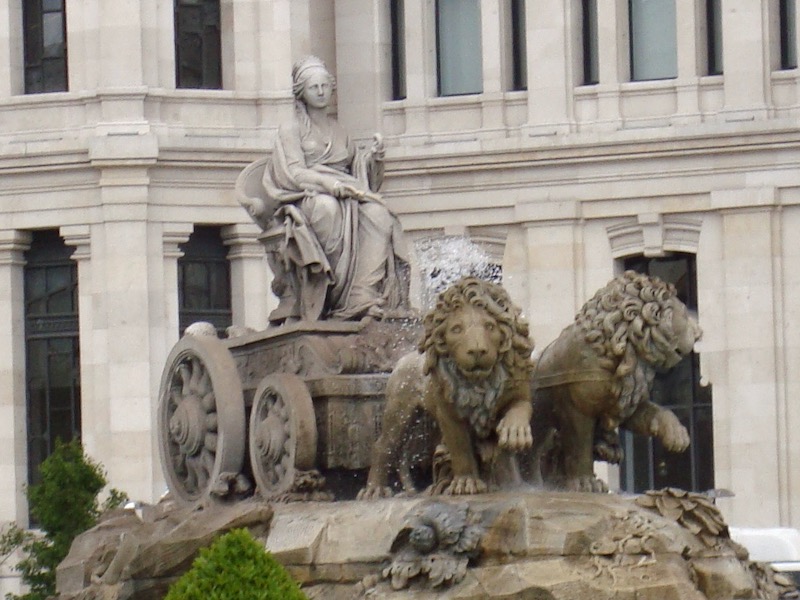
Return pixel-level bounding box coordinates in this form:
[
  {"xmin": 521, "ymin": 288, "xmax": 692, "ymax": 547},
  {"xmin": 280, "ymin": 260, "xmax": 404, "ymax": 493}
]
[{"xmin": 58, "ymin": 59, "xmax": 796, "ymax": 600}]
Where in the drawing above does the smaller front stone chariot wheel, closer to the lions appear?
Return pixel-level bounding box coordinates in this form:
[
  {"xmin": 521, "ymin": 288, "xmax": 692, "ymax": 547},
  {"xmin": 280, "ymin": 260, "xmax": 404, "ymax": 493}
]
[{"xmin": 250, "ymin": 373, "xmax": 317, "ymax": 498}]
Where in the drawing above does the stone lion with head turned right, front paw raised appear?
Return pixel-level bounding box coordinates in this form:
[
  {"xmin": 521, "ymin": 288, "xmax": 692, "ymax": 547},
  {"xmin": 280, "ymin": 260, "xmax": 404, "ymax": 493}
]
[{"xmin": 531, "ymin": 271, "xmax": 701, "ymax": 492}]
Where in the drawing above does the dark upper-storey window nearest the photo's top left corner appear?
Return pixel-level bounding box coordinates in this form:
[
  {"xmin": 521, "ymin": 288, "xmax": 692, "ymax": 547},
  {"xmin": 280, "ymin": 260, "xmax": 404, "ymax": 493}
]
[{"xmin": 22, "ymin": 0, "xmax": 67, "ymax": 94}]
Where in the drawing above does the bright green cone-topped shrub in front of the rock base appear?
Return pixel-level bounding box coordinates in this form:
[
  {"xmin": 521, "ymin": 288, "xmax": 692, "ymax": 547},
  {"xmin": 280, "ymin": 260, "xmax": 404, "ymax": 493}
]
[{"xmin": 164, "ymin": 529, "xmax": 306, "ymax": 600}]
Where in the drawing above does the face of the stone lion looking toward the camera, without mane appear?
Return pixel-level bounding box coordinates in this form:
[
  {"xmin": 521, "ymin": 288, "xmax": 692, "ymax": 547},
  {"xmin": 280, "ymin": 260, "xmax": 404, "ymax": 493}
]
[{"xmin": 443, "ymin": 304, "xmax": 505, "ymax": 381}]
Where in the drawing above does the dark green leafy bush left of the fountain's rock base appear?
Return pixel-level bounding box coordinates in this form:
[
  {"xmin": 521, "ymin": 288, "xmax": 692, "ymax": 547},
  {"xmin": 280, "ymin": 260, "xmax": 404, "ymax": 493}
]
[{"xmin": 0, "ymin": 440, "xmax": 127, "ymax": 600}]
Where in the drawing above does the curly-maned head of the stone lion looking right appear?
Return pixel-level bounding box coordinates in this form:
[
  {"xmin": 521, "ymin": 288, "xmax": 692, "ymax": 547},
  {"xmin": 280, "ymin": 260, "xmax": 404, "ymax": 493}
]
[{"xmin": 576, "ymin": 271, "xmax": 702, "ymax": 418}]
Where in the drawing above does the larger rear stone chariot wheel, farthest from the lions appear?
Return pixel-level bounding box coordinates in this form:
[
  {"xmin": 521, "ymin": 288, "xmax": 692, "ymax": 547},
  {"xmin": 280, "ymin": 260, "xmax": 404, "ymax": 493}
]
[{"xmin": 158, "ymin": 335, "xmax": 246, "ymax": 504}]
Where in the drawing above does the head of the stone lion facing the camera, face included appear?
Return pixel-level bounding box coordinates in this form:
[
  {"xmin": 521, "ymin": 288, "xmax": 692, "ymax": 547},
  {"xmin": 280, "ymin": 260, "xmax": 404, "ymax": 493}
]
[{"xmin": 419, "ymin": 277, "xmax": 533, "ymax": 379}]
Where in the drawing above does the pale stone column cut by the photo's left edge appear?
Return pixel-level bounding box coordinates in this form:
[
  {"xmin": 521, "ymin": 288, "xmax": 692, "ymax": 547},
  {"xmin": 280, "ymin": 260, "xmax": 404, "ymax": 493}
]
[{"xmin": 0, "ymin": 229, "xmax": 31, "ymax": 526}]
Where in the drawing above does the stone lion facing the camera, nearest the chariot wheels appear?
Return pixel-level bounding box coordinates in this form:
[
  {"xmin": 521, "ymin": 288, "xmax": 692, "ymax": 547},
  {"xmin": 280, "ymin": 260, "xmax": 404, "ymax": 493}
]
[{"xmin": 359, "ymin": 277, "xmax": 533, "ymax": 498}]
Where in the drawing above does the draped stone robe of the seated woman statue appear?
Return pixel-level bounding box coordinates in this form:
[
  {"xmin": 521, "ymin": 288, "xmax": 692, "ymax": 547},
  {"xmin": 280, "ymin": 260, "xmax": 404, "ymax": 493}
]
[{"xmin": 263, "ymin": 118, "xmax": 408, "ymax": 320}]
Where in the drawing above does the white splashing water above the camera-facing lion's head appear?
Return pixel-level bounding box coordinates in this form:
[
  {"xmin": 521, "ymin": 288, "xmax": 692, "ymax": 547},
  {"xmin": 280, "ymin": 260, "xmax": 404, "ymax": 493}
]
[{"xmin": 414, "ymin": 235, "xmax": 502, "ymax": 310}]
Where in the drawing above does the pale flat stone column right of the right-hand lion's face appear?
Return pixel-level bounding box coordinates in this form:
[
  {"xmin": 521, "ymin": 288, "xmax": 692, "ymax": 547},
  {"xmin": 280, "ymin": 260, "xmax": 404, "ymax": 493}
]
[{"xmin": 698, "ymin": 188, "xmax": 786, "ymax": 527}]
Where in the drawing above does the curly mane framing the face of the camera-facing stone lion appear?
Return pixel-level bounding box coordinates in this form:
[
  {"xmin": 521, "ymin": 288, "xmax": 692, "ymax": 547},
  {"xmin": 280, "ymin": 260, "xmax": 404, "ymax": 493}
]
[{"xmin": 419, "ymin": 277, "xmax": 533, "ymax": 437}]
